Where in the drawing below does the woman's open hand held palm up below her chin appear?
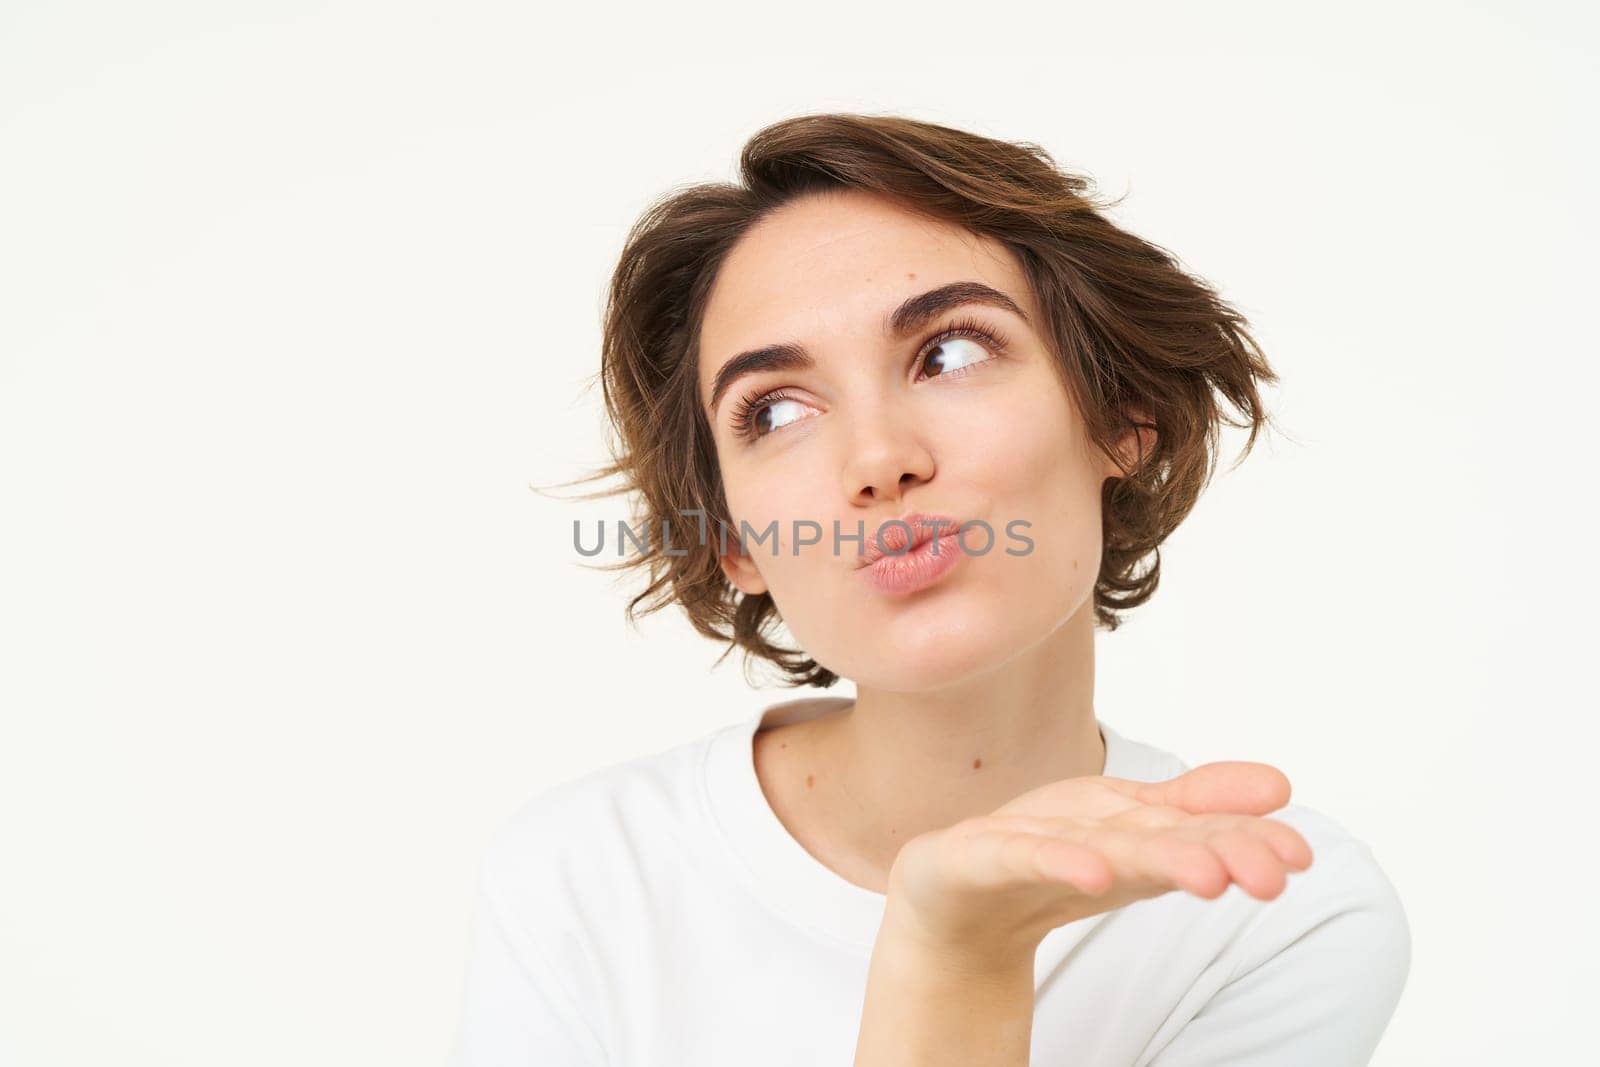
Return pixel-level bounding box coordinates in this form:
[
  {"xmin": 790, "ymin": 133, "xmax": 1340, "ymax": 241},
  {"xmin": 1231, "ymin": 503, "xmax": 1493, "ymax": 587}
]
[{"xmin": 880, "ymin": 760, "xmax": 1312, "ymax": 973}]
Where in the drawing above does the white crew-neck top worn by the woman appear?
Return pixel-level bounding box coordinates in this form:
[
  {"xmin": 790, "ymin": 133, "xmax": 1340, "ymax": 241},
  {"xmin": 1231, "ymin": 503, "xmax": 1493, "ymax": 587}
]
[{"xmin": 453, "ymin": 701, "xmax": 1411, "ymax": 1067}]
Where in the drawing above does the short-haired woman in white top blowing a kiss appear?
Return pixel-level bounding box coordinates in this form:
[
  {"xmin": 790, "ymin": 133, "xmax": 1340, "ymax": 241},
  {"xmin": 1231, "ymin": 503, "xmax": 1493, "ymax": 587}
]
[{"xmin": 456, "ymin": 115, "xmax": 1410, "ymax": 1067}]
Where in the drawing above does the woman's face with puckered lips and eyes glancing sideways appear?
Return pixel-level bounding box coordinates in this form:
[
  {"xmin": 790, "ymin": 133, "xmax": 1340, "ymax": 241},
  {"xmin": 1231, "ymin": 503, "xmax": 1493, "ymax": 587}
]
[{"xmin": 698, "ymin": 190, "xmax": 1139, "ymax": 691}]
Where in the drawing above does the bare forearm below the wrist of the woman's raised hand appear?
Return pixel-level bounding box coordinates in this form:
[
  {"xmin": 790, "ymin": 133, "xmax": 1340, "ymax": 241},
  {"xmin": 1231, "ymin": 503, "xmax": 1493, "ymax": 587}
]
[{"xmin": 854, "ymin": 929, "xmax": 1034, "ymax": 1067}]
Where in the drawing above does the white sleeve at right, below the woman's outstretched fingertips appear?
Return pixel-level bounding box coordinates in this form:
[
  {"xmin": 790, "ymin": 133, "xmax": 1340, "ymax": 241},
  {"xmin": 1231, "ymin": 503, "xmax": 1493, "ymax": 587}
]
[{"xmin": 1149, "ymin": 843, "xmax": 1411, "ymax": 1067}]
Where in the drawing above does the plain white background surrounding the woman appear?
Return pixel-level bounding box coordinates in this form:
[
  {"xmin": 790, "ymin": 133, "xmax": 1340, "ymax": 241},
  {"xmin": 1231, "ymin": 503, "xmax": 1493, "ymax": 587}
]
[{"xmin": 0, "ymin": 0, "xmax": 1600, "ymax": 1067}]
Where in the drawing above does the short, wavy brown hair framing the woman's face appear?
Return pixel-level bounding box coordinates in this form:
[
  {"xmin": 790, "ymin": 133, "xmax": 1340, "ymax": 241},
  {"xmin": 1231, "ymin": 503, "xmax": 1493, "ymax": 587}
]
[{"xmin": 550, "ymin": 114, "xmax": 1278, "ymax": 686}]
